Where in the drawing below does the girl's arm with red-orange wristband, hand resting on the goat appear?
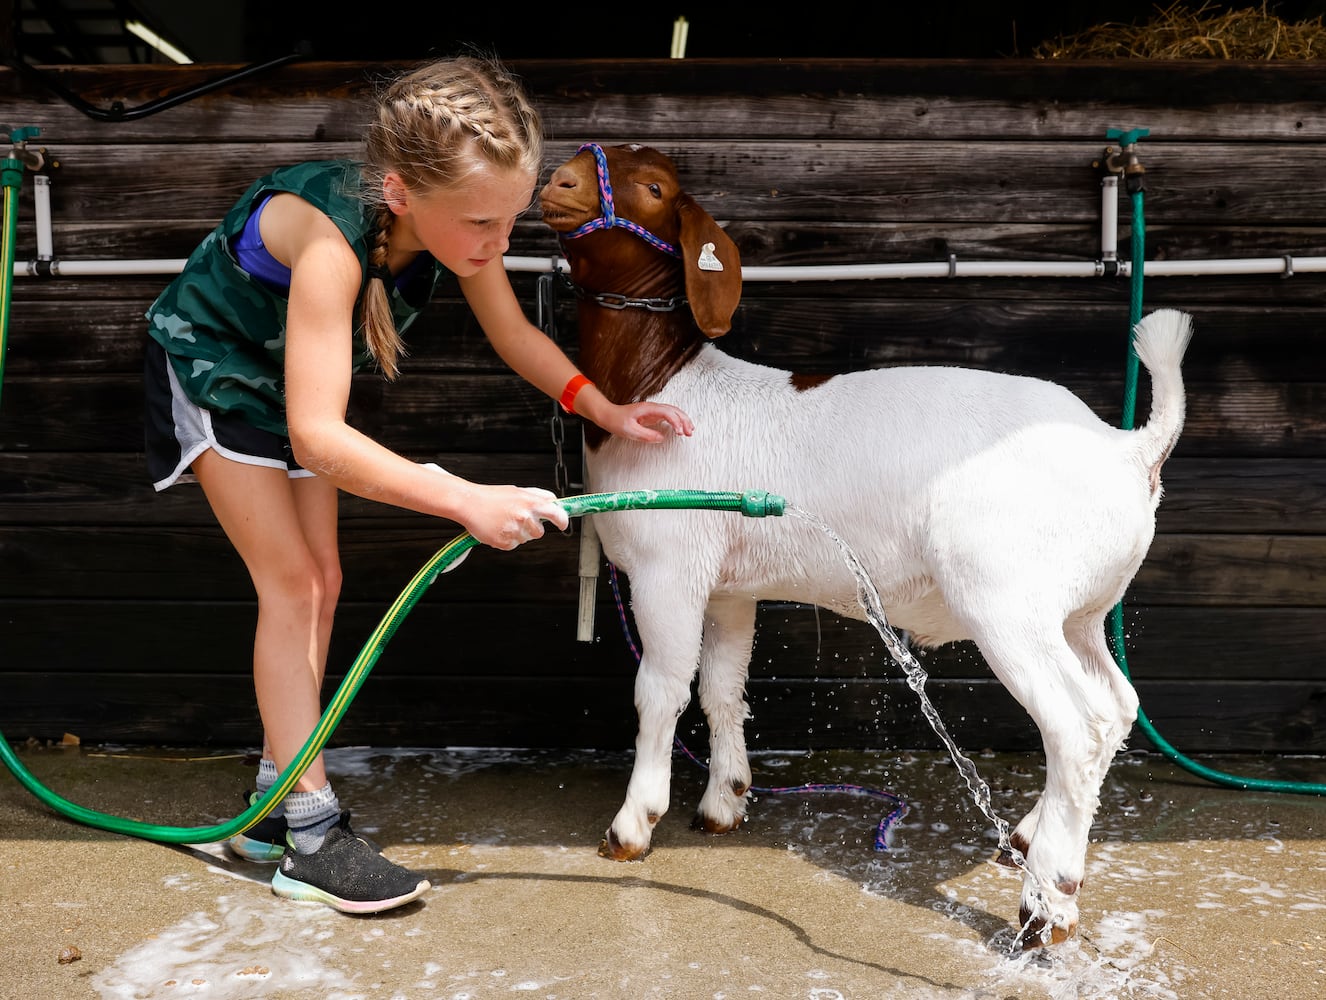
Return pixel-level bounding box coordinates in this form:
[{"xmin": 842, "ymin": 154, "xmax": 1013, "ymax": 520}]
[{"xmin": 460, "ymin": 259, "xmax": 693, "ymax": 442}]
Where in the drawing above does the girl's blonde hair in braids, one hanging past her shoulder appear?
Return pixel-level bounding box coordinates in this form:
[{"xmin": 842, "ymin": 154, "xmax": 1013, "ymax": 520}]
[{"xmin": 363, "ymin": 56, "xmax": 542, "ymax": 378}]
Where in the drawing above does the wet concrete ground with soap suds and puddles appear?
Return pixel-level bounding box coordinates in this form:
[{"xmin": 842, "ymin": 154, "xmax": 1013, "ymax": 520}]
[{"xmin": 0, "ymin": 747, "xmax": 1326, "ymax": 1000}]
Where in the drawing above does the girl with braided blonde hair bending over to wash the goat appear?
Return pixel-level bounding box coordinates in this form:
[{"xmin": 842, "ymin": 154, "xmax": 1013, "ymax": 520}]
[{"xmin": 146, "ymin": 57, "xmax": 692, "ymax": 912}]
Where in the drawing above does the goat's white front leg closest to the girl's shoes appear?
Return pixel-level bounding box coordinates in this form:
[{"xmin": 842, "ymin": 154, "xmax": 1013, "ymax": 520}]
[{"xmin": 598, "ymin": 578, "xmax": 704, "ymax": 861}]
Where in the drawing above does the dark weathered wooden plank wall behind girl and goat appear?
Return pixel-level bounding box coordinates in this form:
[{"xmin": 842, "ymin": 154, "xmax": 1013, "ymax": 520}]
[{"xmin": 0, "ymin": 60, "xmax": 1326, "ymax": 753}]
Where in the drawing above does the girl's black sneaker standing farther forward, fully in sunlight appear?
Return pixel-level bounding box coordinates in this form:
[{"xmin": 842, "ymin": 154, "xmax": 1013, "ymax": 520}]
[{"xmin": 272, "ymin": 812, "xmax": 432, "ymax": 914}]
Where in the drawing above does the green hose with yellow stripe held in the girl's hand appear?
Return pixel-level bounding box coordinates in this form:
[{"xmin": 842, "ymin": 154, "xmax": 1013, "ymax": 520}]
[{"xmin": 0, "ymin": 489, "xmax": 786, "ymax": 844}]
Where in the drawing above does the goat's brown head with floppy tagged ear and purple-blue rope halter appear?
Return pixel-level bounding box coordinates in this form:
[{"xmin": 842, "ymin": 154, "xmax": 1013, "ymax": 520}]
[{"xmin": 538, "ymin": 143, "xmax": 741, "ymax": 337}]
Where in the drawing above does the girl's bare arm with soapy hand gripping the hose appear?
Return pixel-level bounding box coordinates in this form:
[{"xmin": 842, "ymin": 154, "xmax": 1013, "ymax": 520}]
[{"xmin": 263, "ymin": 195, "xmax": 566, "ymax": 549}]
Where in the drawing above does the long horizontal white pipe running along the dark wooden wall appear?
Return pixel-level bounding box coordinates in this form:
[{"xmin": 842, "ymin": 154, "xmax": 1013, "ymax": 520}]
[{"xmin": 13, "ymin": 253, "xmax": 1326, "ymax": 281}]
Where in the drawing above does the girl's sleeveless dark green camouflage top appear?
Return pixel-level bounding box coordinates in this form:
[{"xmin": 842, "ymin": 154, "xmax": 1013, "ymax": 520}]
[{"xmin": 147, "ymin": 160, "xmax": 443, "ymax": 436}]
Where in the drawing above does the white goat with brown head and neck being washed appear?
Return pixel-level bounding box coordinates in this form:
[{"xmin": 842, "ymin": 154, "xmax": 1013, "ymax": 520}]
[{"xmin": 540, "ymin": 143, "xmax": 1191, "ymax": 948}]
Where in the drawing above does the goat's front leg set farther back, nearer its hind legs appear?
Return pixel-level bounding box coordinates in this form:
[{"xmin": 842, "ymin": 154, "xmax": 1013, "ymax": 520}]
[{"xmin": 691, "ymin": 597, "xmax": 756, "ymax": 833}]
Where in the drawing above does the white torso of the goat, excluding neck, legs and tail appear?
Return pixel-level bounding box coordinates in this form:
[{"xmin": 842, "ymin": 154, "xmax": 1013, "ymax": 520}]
[{"xmin": 587, "ymin": 345, "xmax": 1158, "ymax": 645}]
